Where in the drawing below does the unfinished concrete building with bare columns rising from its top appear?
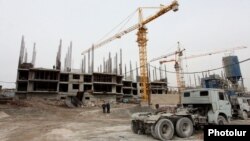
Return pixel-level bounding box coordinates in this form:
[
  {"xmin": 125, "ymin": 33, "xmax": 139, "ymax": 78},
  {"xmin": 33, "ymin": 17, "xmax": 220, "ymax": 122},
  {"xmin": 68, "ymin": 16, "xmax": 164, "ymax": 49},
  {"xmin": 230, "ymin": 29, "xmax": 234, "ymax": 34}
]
[{"xmin": 16, "ymin": 37, "xmax": 168, "ymax": 102}]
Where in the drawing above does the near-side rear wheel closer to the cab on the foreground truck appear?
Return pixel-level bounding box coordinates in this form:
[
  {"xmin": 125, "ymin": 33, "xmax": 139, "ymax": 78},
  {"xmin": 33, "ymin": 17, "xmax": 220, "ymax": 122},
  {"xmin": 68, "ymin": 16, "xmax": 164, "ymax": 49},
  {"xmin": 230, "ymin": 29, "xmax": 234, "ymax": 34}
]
[{"xmin": 175, "ymin": 117, "xmax": 194, "ymax": 138}]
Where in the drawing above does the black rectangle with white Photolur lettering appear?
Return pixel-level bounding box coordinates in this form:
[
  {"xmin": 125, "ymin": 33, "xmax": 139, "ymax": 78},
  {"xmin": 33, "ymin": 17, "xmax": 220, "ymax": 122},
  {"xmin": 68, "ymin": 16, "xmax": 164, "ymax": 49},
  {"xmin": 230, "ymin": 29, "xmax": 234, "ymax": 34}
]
[{"xmin": 204, "ymin": 125, "xmax": 250, "ymax": 141}]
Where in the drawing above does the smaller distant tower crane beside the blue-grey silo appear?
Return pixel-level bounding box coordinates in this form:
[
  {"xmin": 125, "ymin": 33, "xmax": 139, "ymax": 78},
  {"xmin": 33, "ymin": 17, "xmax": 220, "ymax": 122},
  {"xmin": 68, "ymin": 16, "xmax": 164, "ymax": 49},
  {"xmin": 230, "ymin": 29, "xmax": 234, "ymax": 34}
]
[{"xmin": 157, "ymin": 43, "xmax": 247, "ymax": 93}]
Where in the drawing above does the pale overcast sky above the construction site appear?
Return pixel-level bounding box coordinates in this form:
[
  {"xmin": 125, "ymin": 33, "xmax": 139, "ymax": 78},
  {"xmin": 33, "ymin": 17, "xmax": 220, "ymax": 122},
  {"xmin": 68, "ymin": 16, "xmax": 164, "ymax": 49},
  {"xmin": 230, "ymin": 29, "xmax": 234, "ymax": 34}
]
[{"xmin": 0, "ymin": 0, "xmax": 250, "ymax": 89}]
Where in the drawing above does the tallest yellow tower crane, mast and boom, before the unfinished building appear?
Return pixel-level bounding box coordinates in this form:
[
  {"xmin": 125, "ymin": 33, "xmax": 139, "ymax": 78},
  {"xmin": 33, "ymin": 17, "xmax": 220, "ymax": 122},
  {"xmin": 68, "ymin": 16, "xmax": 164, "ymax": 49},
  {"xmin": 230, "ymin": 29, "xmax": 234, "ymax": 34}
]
[{"xmin": 82, "ymin": 0, "xmax": 179, "ymax": 101}]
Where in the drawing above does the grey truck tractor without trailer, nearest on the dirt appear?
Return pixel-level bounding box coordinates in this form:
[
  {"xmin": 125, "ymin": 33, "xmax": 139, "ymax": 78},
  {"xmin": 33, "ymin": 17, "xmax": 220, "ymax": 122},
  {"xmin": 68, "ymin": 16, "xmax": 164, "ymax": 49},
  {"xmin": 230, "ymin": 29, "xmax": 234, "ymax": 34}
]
[{"xmin": 131, "ymin": 88, "xmax": 232, "ymax": 140}]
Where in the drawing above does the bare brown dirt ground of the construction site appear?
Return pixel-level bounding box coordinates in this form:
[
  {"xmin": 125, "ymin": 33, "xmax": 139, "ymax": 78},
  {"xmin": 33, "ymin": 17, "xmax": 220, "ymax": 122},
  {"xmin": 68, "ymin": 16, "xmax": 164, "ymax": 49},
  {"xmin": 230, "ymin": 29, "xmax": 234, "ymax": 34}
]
[{"xmin": 0, "ymin": 99, "xmax": 250, "ymax": 141}]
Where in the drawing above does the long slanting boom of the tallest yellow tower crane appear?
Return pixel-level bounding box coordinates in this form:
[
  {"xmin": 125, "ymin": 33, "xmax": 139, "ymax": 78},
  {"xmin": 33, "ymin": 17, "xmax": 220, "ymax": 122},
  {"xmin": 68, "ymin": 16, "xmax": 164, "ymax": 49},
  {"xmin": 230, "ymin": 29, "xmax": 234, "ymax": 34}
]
[{"xmin": 82, "ymin": 1, "xmax": 178, "ymax": 55}]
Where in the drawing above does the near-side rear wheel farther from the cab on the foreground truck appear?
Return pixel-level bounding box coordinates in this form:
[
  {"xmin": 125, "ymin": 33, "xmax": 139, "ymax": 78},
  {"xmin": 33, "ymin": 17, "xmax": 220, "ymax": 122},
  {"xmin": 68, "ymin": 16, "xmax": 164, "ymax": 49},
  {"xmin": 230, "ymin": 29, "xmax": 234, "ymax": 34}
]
[{"xmin": 155, "ymin": 119, "xmax": 174, "ymax": 141}]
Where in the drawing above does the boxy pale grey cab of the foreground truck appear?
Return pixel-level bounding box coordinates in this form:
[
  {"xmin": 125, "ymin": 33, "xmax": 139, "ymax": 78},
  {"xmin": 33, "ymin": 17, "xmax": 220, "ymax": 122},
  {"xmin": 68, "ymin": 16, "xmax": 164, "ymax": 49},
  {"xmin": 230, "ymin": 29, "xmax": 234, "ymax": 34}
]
[{"xmin": 181, "ymin": 88, "xmax": 232, "ymax": 124}]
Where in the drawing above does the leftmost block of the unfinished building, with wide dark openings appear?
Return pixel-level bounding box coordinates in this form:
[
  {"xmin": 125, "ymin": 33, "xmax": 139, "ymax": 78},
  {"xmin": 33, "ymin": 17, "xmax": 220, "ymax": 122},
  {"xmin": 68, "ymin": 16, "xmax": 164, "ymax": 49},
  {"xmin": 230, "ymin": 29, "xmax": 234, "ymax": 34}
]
[{"xmin": 16, "ymin": 67, "xmax": 60, "ymax": 97}]
